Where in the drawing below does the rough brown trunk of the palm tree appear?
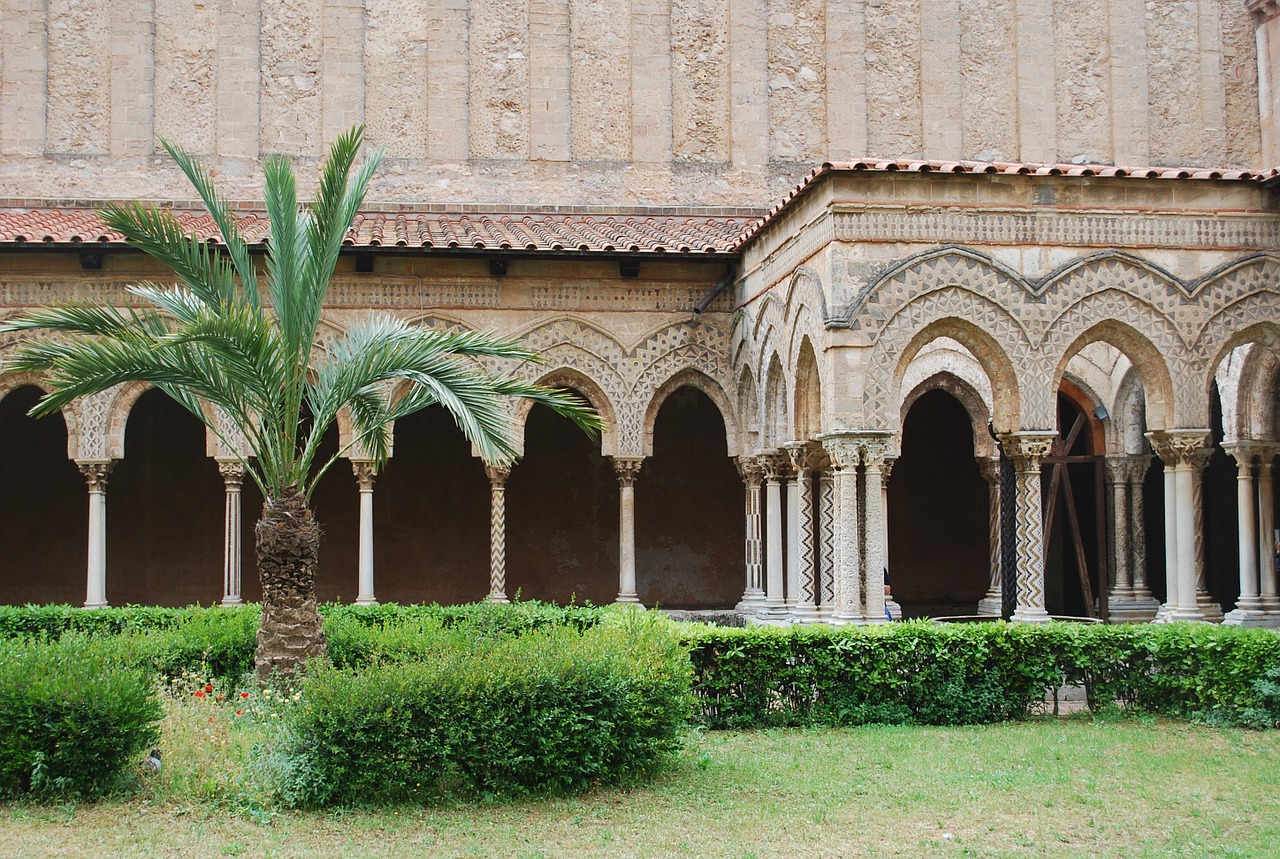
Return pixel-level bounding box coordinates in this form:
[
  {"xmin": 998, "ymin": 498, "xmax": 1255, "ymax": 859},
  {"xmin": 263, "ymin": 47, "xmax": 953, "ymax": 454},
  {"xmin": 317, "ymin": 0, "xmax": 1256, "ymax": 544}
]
[{"xmin": 255, "ymin": 486, "xmax": 326, "ymax": 682}]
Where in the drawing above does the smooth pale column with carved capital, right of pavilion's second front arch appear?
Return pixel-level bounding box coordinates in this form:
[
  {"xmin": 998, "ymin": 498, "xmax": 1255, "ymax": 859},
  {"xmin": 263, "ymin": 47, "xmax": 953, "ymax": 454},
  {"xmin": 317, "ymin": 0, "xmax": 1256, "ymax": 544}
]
[{"xmin": 1147, "ymin": 430, "xmax": 1208, "ymax": 621}]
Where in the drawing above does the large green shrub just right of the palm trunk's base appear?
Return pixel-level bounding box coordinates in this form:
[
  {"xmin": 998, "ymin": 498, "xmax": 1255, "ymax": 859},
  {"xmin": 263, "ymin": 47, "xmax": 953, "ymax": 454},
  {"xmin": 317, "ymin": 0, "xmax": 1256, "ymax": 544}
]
[{"xmin": 262, "ymin": 611, "xmax": 690, "ymax": 805}]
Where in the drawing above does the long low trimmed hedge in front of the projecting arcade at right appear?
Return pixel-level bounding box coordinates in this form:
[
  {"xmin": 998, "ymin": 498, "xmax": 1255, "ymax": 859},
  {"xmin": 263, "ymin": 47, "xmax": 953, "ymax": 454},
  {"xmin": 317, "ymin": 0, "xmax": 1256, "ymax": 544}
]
[{"xmin": 686, "ymin": 622, "xmax": 1280, "ymax": 728}]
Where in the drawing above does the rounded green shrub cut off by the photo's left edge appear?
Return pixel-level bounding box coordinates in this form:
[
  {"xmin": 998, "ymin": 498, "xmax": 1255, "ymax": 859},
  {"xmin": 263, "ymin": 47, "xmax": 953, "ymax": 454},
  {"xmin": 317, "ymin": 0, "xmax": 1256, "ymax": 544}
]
[{"xmin": 0, "ymin": 634, "xmax": 163, "ymax": 798}]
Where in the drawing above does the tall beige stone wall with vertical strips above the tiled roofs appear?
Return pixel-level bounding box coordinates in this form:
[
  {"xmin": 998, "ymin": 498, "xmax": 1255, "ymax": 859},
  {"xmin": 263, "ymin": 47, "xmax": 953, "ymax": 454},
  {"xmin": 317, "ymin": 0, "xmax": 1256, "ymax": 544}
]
[{"xmin": 0, "ymin": 0, "xmax": 1265, "ymax": 205}]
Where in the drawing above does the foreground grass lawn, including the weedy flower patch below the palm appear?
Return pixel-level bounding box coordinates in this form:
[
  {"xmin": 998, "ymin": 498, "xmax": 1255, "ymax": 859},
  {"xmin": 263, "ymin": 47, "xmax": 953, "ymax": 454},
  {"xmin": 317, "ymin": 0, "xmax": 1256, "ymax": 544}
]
[{"xmin": 0, "ymin": 705, "xmax": 1280, "ymax": 859}]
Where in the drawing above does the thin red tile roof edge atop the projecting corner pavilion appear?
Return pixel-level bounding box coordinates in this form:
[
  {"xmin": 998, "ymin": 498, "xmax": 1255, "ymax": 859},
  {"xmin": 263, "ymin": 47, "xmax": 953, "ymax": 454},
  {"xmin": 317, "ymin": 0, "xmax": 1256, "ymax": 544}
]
[{"xmin": 733, "ymin": 160, "xmax": 1280, "ymax": 248}]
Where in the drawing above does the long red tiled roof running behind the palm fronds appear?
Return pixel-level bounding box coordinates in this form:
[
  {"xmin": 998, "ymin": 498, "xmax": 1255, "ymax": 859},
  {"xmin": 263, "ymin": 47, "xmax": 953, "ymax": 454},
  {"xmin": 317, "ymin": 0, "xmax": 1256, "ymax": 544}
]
[{"xmin": 0, "ymin": 202, "xmax": 758, "ymax": 255}]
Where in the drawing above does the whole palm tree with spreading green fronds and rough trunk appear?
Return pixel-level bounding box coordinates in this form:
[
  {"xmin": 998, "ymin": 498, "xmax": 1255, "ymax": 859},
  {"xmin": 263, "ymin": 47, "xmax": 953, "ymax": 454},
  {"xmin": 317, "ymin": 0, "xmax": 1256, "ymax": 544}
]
[{"xmin": 0, "ymin": 128, "xmax": 600, "ymax": 678}]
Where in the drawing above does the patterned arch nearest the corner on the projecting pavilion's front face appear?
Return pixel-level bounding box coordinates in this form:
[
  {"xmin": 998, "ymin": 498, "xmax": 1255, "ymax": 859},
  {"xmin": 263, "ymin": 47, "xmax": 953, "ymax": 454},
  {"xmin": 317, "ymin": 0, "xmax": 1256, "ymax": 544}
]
[{"xmin": 859, "ymin": 295, "xmax": 1029, "ymax": 433}]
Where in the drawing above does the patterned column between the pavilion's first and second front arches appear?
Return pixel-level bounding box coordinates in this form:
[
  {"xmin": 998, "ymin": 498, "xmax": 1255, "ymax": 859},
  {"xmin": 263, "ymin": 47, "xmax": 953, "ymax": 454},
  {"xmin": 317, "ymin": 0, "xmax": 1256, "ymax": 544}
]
[{"xmin": 1001, "ymin": 431, "xmax": 1057, "ymax": 623}]
